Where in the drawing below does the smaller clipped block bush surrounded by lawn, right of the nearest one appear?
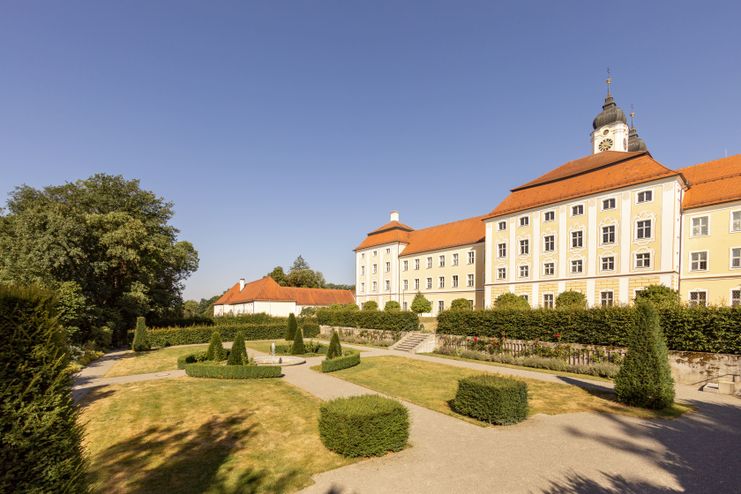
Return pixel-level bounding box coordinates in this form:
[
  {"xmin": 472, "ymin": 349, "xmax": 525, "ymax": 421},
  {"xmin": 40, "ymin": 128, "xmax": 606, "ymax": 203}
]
[{"xmin": 452, "ymin": 374, "xmax": 527, "ymax": 425}]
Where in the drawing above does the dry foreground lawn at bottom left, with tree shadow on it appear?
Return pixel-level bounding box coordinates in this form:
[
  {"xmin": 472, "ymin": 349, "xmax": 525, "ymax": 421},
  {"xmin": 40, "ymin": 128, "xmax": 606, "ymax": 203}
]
[{"xmin": 80, "ymin": 377, "xmax": 351, "ymax": 494}]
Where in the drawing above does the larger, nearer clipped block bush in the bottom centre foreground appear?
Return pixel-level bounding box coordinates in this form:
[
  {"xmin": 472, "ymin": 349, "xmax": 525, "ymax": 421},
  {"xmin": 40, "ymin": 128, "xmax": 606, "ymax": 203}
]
[{"xmin": 319, "ymin": 395, "xmax": 409, "ymax": 457}]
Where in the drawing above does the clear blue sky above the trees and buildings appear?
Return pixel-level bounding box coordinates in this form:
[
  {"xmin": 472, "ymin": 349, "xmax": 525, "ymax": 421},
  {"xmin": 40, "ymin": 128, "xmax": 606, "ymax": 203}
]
[{"xmin": 0, "ymin": 0, "xmax": 741, "ymax": 298}]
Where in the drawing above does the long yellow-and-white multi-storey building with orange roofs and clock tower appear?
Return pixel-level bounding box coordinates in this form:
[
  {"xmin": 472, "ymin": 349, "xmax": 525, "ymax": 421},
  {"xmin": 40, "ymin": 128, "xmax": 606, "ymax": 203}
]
[{"xmin": 355, "ymin": 85, "xmax": 741, "ymax": 308}]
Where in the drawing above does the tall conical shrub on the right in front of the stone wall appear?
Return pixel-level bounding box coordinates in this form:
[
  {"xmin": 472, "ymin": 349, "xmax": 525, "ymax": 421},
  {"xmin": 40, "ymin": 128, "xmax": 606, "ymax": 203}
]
[{"xmin": 615, "ymin": 301, "xmax": 674, "ymax": 409}]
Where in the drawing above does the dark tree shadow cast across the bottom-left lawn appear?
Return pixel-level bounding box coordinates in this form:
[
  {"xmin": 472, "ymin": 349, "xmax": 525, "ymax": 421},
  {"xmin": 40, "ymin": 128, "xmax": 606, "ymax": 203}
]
[{"xmin": 92, "ymin": 414, "xmax": 297, "ymax": 494}]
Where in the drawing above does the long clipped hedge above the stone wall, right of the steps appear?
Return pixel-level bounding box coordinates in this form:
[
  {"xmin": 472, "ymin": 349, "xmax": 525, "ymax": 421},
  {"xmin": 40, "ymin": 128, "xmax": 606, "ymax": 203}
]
[{"xmin": 437, "ymin": 307, "xmax": 741, "ymax": 354}]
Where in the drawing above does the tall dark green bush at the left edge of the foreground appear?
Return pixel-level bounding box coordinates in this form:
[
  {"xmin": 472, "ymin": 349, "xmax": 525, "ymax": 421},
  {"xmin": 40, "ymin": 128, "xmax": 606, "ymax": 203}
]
[{"xmin": 0, "ymin": 285, "xmax": 88, "ymax": 493}]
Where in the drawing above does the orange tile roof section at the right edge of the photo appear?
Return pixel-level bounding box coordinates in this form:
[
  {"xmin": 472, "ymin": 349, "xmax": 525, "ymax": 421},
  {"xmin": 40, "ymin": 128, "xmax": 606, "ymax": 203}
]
[{"xmin": 678, "ymin": 154, "xmax": 741, "ymax": 209}]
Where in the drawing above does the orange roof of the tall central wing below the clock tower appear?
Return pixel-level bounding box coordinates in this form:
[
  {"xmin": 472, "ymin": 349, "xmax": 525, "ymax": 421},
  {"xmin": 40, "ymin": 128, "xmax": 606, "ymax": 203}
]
[{"xmin": 484, "ymin": 151, "xmax": 679, "ymax": 219}]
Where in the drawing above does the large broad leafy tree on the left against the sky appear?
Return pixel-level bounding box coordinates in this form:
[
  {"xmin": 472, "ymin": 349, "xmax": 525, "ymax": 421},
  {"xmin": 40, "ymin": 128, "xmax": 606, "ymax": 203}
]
[{"xmin": 0, "ymin": 174, "xmax": 198, "ymax": 344}]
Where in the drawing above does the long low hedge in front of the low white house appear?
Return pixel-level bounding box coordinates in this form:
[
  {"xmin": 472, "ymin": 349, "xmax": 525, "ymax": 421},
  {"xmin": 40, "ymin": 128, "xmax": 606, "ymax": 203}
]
[{"xmin": 148, "ymin": 323, "xmax": 319, "ymax": 347}]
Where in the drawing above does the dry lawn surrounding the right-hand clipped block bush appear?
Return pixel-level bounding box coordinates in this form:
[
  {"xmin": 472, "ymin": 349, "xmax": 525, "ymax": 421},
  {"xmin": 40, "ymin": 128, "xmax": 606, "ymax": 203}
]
[{"xmin": 324, "ymin": 357, "xmax": 689, "ymax": 424}]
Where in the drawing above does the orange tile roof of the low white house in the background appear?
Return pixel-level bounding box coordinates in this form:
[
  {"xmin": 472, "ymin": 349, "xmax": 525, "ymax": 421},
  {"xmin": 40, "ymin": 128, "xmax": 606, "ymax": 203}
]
[{"xmin": 214, "ymin": 276, "xmax": 355, "ymax": 305}]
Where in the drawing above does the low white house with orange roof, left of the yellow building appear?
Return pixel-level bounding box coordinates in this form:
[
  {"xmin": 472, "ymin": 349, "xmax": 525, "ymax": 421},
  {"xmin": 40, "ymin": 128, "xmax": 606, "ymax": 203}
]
[{"xmin": 214, "ymin": 276, "xmax": 355, "ymax": 317}]
